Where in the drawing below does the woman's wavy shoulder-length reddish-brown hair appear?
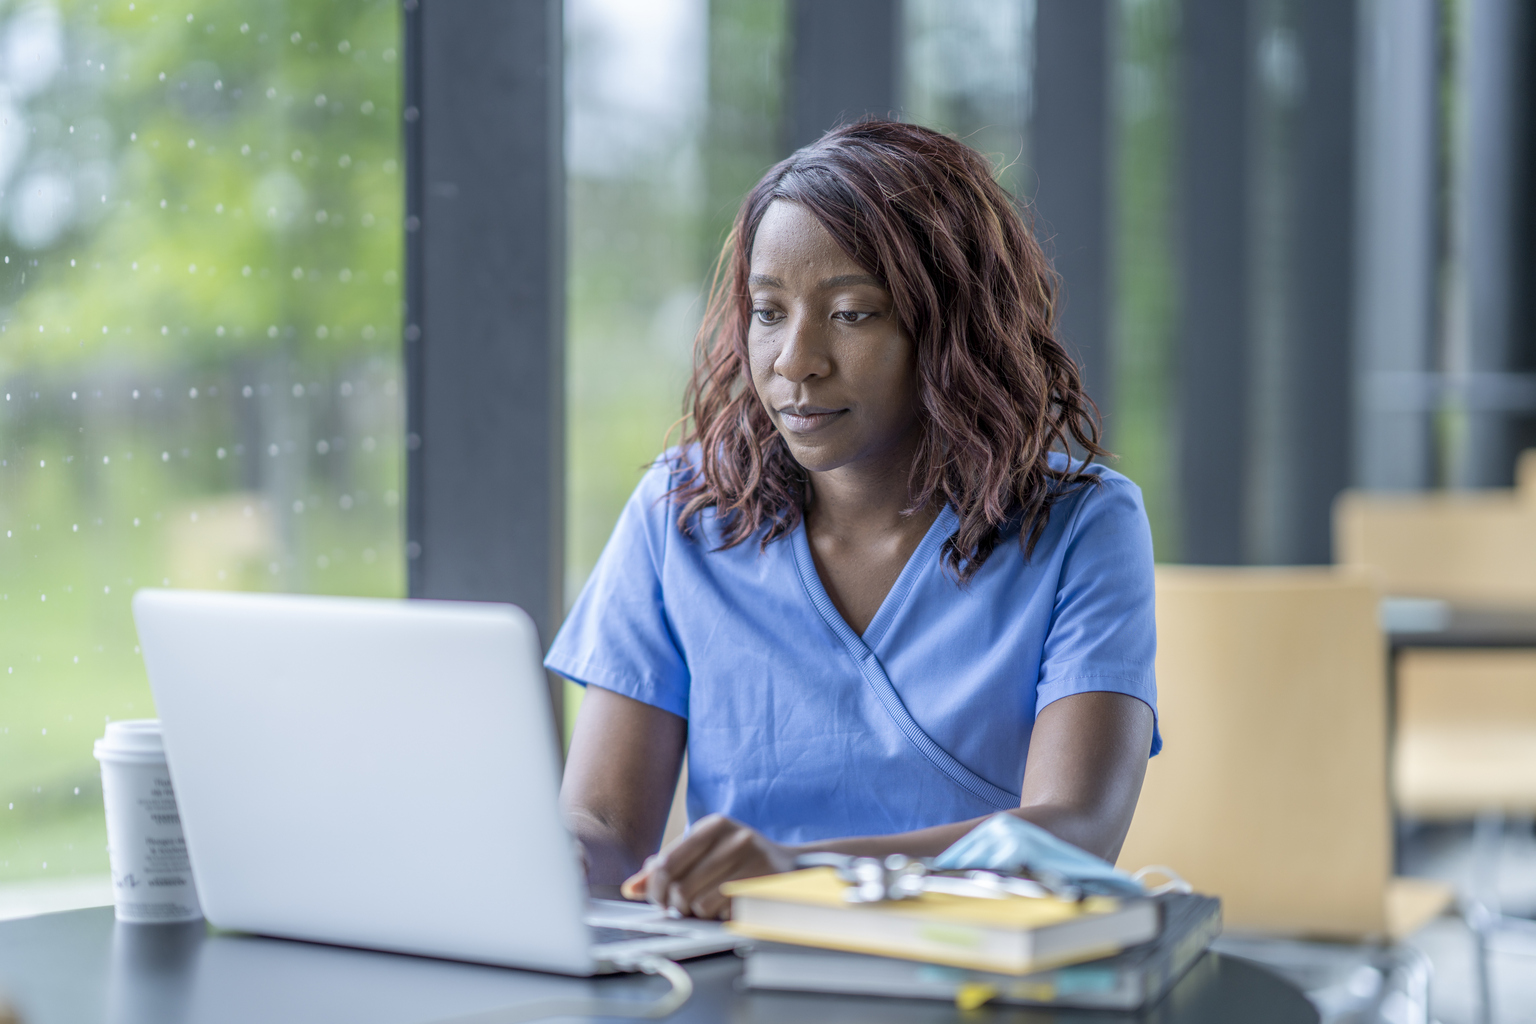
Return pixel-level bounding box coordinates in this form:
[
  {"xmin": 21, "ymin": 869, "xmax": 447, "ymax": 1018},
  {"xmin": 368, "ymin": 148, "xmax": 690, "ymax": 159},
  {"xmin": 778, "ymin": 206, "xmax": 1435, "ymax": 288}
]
[{"xmin": 671, "ymin": 120, "xmax": 1107, "ymax": 582}]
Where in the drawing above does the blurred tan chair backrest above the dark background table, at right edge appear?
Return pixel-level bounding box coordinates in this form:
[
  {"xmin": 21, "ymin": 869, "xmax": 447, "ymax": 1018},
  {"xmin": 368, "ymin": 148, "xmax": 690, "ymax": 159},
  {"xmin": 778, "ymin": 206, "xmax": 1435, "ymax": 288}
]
[{"xmin": 1333, "ymin": 450, "xmax": 1536, "ymax": 603}]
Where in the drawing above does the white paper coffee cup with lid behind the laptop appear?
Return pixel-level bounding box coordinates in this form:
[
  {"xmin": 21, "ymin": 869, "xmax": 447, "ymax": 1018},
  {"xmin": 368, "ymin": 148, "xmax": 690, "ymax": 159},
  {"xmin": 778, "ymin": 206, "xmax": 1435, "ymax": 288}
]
[{"xmin": 95, "ymin": 718, "xmax": 203, "ymax": 923}]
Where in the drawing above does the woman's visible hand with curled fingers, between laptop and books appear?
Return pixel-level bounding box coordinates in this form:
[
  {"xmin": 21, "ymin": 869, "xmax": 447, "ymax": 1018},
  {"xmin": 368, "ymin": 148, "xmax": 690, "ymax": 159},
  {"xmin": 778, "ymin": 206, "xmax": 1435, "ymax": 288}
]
[{"xmin": 622, "ymin": 814, "xmax": 794, "ymax": 921}]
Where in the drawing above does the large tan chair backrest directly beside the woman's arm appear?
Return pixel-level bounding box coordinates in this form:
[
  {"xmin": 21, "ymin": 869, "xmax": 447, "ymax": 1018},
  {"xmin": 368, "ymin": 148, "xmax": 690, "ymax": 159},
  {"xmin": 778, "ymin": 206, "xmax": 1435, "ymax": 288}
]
[{"xmin": 1120, "ymin": 567, "xmax": 1392, "ymax": 938}]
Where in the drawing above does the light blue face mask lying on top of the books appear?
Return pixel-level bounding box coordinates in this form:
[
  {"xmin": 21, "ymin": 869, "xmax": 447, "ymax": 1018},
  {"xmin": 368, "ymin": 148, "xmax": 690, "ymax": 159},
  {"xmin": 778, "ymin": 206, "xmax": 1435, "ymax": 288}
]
[{"xmin": 932, "ymin": 812, "xmax": 1147, "ymax": 897}]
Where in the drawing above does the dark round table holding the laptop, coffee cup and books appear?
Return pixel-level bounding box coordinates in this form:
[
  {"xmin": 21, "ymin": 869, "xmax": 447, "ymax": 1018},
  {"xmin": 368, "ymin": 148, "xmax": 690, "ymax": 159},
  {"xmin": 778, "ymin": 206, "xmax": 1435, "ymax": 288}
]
[{"xmin": 0, "ymin": 907, "xmax": 1318, "ymax": 1024}]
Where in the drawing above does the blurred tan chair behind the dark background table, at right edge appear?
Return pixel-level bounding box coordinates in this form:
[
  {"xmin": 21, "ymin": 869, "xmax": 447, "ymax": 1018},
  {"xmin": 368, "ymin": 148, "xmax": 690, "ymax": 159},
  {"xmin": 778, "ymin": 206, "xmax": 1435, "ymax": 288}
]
[{"xmin": 1333, "ymin": 450, "xmax": 1536, "ymax": 1019}]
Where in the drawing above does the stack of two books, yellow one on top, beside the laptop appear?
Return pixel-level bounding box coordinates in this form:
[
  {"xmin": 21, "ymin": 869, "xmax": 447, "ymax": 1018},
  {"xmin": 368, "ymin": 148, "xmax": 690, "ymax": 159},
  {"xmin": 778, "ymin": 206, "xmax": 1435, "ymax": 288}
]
[{"xmin": 722, "ymin": 867, "xmax": 1221, "ymax": 1010}]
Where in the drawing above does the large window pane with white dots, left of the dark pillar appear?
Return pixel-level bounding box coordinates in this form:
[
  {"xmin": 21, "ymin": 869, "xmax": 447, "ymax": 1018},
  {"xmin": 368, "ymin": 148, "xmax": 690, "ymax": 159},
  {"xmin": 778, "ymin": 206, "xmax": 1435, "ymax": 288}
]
[{"xmin": 0, "ymin": 0, "xmax": 404, "ymax": 884}]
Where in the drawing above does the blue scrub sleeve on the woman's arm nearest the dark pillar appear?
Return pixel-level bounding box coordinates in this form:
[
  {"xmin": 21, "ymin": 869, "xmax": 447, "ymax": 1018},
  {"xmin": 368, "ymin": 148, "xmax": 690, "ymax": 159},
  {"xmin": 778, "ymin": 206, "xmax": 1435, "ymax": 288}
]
[{"xmin": 544, "ymin": 456, "xmax": 688, "ymax": 718}]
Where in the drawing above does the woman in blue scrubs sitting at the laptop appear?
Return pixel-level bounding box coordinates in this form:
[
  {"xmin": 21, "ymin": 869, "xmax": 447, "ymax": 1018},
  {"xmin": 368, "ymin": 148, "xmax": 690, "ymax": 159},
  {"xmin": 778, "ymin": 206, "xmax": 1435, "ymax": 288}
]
[{"xmin": 547, "ymin": 121, "xmax": 1160, "ymax": 918}]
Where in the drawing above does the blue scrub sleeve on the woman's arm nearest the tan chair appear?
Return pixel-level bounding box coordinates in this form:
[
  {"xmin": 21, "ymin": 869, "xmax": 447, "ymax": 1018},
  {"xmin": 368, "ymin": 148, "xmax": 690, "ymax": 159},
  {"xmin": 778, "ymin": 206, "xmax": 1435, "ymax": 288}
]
[{"xmin": 1035, "ymin": 473, "xmax": 1163, "ymax": 754}]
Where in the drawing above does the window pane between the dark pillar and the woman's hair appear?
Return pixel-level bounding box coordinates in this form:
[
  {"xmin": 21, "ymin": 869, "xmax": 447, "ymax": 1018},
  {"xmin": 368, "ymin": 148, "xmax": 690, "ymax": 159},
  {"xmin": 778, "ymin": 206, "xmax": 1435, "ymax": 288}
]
[{"xmin": 565, "ymin": 0, "xmax": 785, "ymax": 723}]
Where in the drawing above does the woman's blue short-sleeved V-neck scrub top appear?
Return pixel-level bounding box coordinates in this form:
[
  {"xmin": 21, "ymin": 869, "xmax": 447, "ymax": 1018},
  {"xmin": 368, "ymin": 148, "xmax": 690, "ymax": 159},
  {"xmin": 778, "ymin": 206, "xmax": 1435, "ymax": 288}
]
[{"xmin": 545, "ymin": 453, "xmax": 1163, "ymax": 843}]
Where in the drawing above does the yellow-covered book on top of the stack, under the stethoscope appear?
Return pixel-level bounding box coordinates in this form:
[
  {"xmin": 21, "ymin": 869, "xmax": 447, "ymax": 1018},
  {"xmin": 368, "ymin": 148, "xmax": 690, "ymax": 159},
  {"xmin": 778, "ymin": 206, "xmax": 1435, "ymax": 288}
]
[{"xmin": 720, "ymin": 867, "xmax": 1158, "ymax": 975}]
